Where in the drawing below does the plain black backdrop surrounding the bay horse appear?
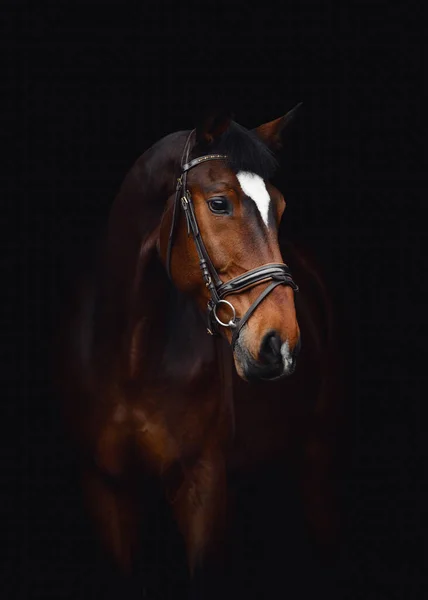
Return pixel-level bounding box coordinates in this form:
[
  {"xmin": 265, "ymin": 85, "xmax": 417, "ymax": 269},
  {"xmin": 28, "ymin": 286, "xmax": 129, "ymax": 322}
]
[{"xmin": 4, "ymin": 0, "xmax": 428, "ymax": 600}]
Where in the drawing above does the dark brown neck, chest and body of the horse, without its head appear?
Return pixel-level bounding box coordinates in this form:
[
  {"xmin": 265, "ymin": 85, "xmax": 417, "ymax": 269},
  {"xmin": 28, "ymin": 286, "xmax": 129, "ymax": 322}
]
[{"xmin": 60, "ymin": 111, "xmax": 339, "ymax": 596}]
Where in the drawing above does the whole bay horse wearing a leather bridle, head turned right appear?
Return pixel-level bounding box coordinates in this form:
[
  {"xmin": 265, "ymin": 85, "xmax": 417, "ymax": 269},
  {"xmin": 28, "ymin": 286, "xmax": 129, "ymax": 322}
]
[{"xmin": 58, "ymin": 107, "xmax": 340, "ymax": 598}]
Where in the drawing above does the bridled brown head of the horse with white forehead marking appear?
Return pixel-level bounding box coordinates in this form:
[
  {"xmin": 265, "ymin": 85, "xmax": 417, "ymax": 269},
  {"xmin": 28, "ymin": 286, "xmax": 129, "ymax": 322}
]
[{"xmin": 157, "ymin": 109, "xmax": 300, "ymax": 380}]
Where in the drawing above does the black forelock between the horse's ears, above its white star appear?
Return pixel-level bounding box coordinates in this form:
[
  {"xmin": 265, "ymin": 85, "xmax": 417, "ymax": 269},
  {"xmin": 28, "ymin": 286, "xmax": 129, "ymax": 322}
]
[{"xmin": 206, "ymin": 121, "xmax": 278, "ymax": 179}]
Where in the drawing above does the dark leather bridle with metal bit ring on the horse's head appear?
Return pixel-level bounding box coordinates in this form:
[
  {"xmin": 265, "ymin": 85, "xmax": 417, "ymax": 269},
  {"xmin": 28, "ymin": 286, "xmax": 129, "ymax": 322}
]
[{"xmin": 166, "ymin": 131, "xmax": 299, "ymax": 350}]
